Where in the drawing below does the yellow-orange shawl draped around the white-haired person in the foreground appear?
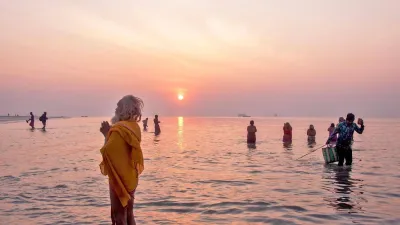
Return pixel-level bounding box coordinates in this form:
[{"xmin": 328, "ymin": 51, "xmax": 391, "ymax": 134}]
[{"xmin": 100, "ymin": 121, "xmax": 144, "ymax": 207}]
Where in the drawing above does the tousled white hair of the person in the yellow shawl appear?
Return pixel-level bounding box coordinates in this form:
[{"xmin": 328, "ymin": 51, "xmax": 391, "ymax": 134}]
[{"xmin": 111, "ymin": 95, "xmax": 144, "ymax": 124}]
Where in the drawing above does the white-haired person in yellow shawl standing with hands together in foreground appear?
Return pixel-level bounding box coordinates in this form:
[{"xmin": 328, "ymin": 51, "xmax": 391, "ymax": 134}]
[{"xmin": 100, "ymin": 95, "xmax": 144, "ymax": 225}]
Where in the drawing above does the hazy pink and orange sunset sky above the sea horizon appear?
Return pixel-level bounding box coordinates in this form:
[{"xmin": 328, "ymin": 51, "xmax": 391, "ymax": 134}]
[{"xmin": 0, "ymin": 0, "xmax": 400, "ymax": 117}]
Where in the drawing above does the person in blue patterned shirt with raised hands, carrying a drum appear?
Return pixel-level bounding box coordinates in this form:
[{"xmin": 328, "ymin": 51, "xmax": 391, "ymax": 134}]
[{"xmin": 326, "ymin": 113, "xmax": 364, "ymax": 166}]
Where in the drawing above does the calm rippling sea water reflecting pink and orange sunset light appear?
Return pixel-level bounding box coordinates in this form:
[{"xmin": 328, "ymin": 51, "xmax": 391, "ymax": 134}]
[{"xmin": 0, "ymin": 117, "xmax": 400, "ymax": 224}]
